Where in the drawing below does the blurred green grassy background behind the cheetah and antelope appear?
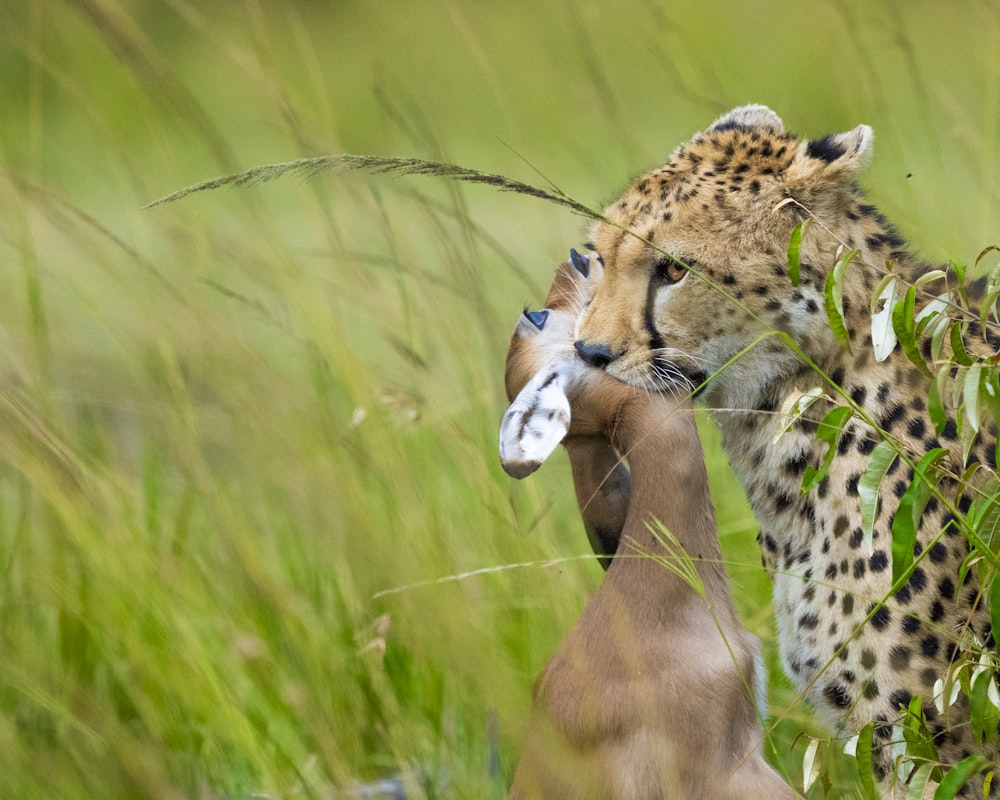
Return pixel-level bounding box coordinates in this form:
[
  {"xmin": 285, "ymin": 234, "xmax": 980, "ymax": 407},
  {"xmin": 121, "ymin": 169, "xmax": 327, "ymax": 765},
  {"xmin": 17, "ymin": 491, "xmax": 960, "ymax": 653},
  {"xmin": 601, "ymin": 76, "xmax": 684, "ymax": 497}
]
[{"xmin": 0, "ymin": 0, "xmax": 1000, "ymax": 798}]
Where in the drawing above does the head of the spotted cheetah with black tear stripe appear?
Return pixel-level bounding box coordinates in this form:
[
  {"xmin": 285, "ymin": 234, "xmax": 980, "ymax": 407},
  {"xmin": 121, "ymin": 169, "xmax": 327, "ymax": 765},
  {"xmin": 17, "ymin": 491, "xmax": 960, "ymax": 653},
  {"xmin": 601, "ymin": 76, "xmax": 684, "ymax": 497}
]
[{"xmin": 576, "ymin": 105, "xmax": 872, "ymax": 405}]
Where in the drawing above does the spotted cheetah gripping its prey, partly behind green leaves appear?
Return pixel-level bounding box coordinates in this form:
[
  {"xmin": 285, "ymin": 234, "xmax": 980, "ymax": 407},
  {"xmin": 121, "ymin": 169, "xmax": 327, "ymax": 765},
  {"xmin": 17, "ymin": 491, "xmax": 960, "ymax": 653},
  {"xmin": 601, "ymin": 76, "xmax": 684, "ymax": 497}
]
[{"xmin": 575, "ymin": 105, "xmax": 1000, "ymax": 797}]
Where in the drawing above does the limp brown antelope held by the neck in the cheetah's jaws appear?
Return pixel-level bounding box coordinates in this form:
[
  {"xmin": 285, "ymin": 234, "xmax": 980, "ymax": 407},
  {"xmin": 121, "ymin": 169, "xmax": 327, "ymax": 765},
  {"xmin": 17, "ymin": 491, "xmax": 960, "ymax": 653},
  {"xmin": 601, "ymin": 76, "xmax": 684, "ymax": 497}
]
[{"xmin": 500, "ymin": 252, "xmax": 797, "ymax": 800}]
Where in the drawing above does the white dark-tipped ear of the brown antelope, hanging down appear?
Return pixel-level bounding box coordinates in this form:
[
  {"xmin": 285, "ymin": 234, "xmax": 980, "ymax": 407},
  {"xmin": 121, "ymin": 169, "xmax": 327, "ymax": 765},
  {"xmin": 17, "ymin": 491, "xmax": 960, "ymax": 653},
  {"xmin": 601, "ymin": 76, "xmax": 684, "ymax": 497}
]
[{"xmin": 499, "ymin": 361, "xmax": 574, "ymax": 478}]
